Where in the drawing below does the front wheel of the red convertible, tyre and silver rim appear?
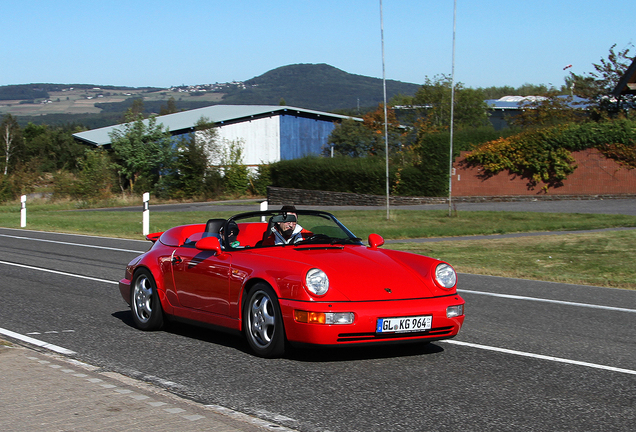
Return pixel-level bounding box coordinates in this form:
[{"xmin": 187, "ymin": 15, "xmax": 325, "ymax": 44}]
[{"xmin": 243, "ymin": 283, "xmax": 286, "ymax": 358}]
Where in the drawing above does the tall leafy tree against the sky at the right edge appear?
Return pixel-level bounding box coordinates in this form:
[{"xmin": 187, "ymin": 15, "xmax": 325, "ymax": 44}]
[{"xmin": 566, "ymin": 44, "xmax": 636, "ymax": 119}]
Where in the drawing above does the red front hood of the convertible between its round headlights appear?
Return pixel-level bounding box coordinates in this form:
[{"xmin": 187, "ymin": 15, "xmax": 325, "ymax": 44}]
[{"xmin": 253, "ymin": 246, "xmax": 448, "ymax": 301}]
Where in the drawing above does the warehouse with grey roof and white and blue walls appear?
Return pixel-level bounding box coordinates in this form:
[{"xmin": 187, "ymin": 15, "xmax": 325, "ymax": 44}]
[{"xmin": 73, "ymin": 105, "xmax": 361, "ymax": 166}]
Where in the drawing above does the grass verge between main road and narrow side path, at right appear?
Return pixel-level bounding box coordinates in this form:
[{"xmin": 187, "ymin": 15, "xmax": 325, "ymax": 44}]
[{"xmin": 385, "ymin": 230, "xmax": 636, "ymax": 289}]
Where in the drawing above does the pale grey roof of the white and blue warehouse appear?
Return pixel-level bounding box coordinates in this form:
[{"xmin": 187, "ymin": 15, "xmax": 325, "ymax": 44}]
[{"xmin": 73, "ymin": 105, "xmax": 358, "ymax": 146}]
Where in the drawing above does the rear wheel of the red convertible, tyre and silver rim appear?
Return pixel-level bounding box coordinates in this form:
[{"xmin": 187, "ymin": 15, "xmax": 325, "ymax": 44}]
[{"xmin": 130, "ymin": 269, "xmax": 163, "ymax": 331}]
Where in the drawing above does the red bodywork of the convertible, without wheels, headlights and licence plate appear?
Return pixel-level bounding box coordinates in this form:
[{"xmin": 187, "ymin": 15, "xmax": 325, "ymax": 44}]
[{"xmin": 119, "ymin": 216, "xmax": 464, "ymax": 345}]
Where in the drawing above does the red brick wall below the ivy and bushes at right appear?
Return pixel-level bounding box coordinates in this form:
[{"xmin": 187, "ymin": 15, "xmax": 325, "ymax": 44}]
[{"xmin": 452, "ymin": 149, "xmax": 636, "ymax": 196}]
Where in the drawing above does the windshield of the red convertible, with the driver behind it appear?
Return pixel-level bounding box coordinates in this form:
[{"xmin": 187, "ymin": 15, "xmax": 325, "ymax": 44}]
[{"xmin": 221, "ymin": 210, "xmax": 362, "ymax": 249}]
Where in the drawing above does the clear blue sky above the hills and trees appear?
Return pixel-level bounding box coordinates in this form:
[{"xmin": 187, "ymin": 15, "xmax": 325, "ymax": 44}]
[{"xmin": 0, "ymin": 0, "xmax": 636, "ymax": 88}]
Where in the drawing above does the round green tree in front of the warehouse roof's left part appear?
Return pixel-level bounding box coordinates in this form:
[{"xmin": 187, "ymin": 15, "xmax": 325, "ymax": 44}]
[{"xmin": 110, "ymin": 114, "xmax": 174, "ymax": 193}]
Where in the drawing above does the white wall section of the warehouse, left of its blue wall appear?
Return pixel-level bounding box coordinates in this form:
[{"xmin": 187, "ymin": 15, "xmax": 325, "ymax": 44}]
[{"xmin": 217, "ymin": 116, "xmax": 280, "ymax": 166}]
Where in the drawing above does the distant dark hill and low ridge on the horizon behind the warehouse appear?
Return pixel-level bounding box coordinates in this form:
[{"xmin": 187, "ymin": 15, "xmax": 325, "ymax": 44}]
[{"xmin": 0, "ymin": 64, "xmax": 420, "ymax": 128}]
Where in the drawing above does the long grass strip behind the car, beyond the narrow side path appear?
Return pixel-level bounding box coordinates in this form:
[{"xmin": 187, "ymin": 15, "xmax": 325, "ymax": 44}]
[{"xmin": 0, "ymin": 203, "xmax": 636, "ymax": 239}]
